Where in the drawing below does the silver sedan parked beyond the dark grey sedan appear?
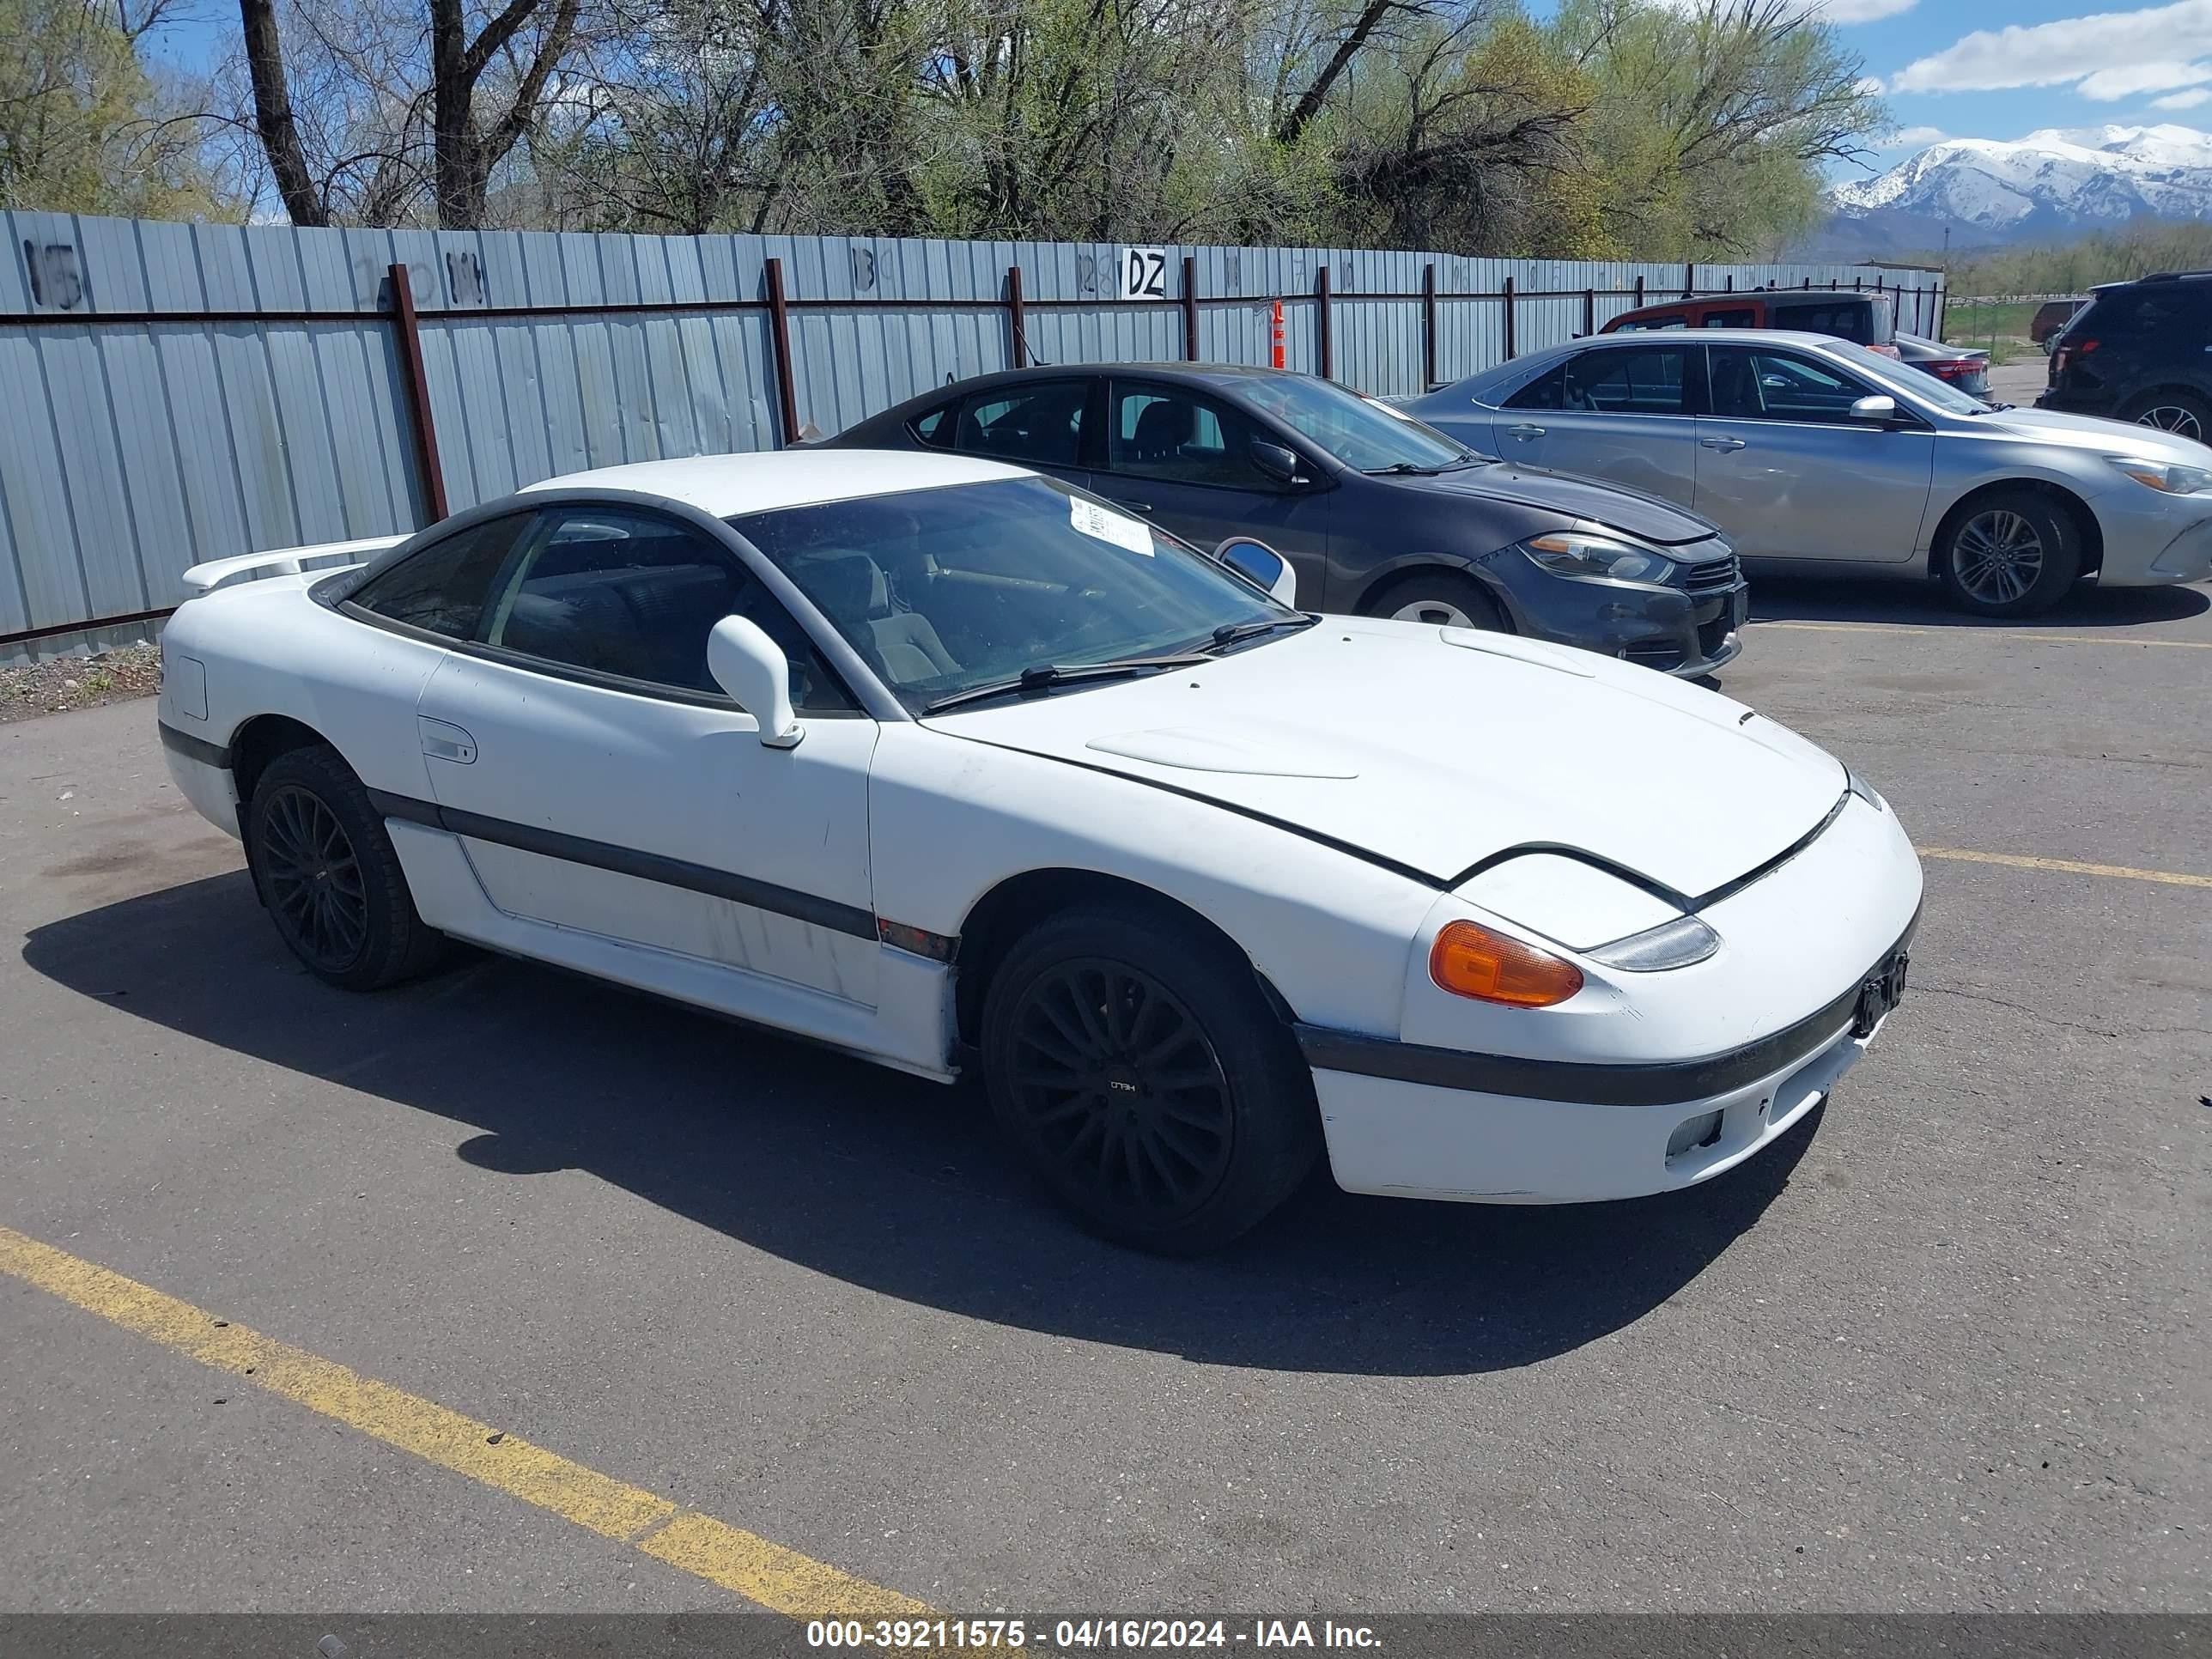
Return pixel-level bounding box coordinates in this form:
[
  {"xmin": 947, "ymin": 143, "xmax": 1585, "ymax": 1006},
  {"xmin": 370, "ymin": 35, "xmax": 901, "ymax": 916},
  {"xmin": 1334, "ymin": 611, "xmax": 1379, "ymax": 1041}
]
[{"xmin": 1405, "ymin": 327, "xmax": 2212, "ymax": 617}]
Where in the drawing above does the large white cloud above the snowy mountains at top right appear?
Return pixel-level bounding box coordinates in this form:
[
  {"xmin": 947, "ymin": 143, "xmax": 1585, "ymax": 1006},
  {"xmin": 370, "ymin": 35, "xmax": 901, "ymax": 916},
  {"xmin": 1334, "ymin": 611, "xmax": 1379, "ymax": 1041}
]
[{"xmin": 1889, "ymin": 0, "xmax": 2212, "ymax": 97}]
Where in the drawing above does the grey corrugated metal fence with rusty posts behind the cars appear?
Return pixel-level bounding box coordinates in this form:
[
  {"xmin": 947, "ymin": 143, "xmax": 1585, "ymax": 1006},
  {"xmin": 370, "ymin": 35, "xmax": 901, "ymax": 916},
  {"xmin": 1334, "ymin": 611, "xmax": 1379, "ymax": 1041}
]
[{"xmin": 0, "ymin": 212, "xmax": 1942, "ymax": 659}]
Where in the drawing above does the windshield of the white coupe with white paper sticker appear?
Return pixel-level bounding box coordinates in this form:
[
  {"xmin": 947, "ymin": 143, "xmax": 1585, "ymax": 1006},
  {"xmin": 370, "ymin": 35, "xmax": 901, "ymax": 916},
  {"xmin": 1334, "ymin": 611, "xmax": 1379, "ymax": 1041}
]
[{"xmin": 730, "ymin": 473, "xmax": 1291, "ymax": 712}]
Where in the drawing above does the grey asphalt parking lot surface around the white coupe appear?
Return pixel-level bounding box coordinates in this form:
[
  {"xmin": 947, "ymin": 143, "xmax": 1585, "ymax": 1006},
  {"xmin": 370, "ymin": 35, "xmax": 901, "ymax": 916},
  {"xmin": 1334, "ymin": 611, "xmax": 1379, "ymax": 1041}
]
[{"xmin": 0, "ymin": 584, "xmax": 2212, "ymax": 1613}]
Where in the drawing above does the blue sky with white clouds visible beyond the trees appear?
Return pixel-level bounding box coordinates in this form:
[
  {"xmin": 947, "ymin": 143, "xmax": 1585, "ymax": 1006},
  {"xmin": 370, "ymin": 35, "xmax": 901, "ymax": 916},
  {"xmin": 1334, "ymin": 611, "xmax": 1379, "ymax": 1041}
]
[{"xmin": 161, "ymin": 0, "xmax": 2212, "ymax": 168}]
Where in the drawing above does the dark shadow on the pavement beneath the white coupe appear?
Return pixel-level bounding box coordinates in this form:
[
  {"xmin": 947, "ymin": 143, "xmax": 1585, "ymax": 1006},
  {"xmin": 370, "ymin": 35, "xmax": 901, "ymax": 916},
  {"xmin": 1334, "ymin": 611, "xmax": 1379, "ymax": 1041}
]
[{"xmin": 24, "ymin": 872, "xmax": 1816, "ymax": 1376}]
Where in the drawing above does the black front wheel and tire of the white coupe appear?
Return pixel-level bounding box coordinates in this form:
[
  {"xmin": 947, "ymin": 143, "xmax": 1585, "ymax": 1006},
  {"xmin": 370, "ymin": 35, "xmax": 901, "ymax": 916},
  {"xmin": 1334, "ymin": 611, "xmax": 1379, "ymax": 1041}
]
[{"xmin": 982, "ymin": 905, "xmax": 1321, "ymax": 1255}]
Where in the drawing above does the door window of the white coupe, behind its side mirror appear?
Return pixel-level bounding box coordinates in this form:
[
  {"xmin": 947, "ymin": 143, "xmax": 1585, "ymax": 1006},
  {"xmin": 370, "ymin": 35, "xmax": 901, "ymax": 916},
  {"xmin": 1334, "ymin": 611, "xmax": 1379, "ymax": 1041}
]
[{"xmin": 484, "ymin": 507, "xmax": 852, "ymax": 712}]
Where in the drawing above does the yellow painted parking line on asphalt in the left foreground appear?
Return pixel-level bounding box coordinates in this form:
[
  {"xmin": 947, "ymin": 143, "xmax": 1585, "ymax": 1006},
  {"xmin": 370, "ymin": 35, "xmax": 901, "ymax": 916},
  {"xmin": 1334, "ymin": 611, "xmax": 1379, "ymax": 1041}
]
[{"xmin": 0, "ymin": 1228, "xmax": 931, "ymax": 1620}]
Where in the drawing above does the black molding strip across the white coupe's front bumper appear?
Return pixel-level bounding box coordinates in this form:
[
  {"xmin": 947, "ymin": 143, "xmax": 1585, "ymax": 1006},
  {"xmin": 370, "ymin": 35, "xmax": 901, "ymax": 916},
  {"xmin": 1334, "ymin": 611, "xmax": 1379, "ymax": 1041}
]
[{"xmin": 1294, "ymin": 911, "xmax": 1920, "ymax": 1106}]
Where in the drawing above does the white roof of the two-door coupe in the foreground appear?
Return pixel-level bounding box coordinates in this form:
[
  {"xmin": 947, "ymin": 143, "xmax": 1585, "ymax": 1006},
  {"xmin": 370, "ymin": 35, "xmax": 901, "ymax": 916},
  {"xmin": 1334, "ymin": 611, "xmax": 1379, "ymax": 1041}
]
[{"xmin": 522, "ymin": 449, "xmax": 1029, "ymax": 518}]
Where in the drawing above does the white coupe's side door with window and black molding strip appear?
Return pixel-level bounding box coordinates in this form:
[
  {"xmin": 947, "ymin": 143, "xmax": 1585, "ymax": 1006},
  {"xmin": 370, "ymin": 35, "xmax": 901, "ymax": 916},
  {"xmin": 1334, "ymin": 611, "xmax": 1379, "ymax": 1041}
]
[{"xmin": 418, "ymin": 504, "xmax": 878, "ymax": 1005}]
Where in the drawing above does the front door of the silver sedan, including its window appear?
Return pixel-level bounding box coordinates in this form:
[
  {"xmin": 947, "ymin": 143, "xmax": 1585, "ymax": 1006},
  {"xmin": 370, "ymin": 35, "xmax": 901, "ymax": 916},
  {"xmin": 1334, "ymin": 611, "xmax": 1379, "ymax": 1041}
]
[{"xmin": 1690, "ymin": 345, "xmax": 1936, "ymax": 564}]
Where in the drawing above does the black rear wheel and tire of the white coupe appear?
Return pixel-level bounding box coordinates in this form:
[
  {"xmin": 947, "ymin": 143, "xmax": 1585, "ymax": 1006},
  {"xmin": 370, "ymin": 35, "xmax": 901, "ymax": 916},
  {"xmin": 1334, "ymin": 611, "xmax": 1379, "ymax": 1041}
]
[{"xmin": 246, "ymin": 745, "xmax": 445, "ymax": 991}]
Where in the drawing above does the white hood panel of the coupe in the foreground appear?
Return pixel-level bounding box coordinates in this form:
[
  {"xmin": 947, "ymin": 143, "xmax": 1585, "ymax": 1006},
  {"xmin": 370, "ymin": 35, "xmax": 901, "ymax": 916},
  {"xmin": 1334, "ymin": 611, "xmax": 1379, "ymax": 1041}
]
[{"xmin": 927, "ymin": 617, "xmax": 1844, "ymax": 896}]
